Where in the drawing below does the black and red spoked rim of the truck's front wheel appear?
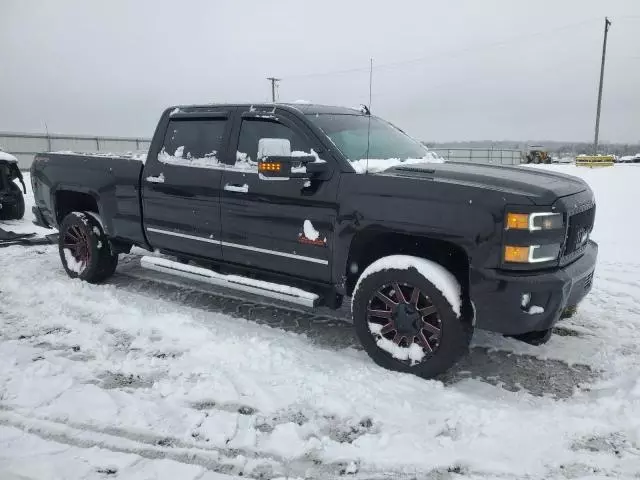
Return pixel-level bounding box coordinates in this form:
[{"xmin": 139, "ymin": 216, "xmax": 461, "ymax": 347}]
[{"xmin": 367, "ymin": 282, "xmax": 442, "ymax": 364}]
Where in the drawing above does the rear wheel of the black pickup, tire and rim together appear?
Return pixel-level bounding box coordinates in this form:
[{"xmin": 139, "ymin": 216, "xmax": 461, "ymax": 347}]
[{"xmin": 58, "ymin": 212, "xmax": 118, "ymax": 283}]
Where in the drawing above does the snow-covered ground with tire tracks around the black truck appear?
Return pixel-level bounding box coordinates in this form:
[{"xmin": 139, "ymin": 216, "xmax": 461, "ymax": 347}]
[{"xmin": 0, "ymin": 165, "xmax": 640, "ymax": 480}]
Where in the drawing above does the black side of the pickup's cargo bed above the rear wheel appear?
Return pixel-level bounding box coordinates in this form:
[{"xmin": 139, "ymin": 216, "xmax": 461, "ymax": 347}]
[{"xmin": 31, "ymin": 151, "xmax": 146, "ymax": 245}]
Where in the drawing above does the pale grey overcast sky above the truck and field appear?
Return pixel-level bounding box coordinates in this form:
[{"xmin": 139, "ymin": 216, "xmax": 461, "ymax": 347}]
[{"xmin": 0, "ymin": 0, "xmax": 640, "ymax": 142}]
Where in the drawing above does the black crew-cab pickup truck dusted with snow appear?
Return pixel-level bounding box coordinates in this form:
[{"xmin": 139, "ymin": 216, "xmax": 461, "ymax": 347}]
[{"xmin": 31, "ymin": 104, "xmax": 597, "ymax": 377}]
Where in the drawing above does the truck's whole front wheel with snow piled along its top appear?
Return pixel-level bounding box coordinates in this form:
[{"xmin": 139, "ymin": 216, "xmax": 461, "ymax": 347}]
[{"xmin": 352, "ymin": 255, "xmax": 473, "ymax": 378}]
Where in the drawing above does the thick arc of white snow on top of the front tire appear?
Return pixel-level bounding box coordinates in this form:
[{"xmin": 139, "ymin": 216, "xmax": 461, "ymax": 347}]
[{"xmin": 352, "ymin": 255, "xmax": 462, "ymax": 318}]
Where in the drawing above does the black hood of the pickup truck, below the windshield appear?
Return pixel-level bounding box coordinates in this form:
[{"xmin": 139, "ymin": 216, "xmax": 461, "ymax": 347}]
[{"xmin": 379, "ymin": 162, "xmax": 589, "ymax": 205}]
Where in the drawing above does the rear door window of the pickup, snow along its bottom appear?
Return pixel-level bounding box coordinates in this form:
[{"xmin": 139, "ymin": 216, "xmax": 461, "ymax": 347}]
[{"xmin": 158, "ymin": 118, "xmax": 227, "ymax": 168}]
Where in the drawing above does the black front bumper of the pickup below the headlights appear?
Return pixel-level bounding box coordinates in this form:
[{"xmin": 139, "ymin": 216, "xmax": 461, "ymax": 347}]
[{"xmin": 470, "ymin": 241, "xmax": 598, "ymax": 335}]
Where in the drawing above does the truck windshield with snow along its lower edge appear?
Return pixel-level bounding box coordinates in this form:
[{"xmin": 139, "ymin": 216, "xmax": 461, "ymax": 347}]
[{"xmin": 307, "ymin": 113, "xmax": 437, "ymax": 171}]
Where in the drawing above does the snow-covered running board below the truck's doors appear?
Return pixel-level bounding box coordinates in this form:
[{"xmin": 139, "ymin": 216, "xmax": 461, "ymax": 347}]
[{"xmin": 140, "ymin": 256, "xmax": 319, "ymax": 307}]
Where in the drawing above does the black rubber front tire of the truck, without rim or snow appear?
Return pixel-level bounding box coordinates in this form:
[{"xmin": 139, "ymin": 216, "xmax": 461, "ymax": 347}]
[{"xmin": 352, "ymin": 258, "xmax": 473, "ymax": 378}]
